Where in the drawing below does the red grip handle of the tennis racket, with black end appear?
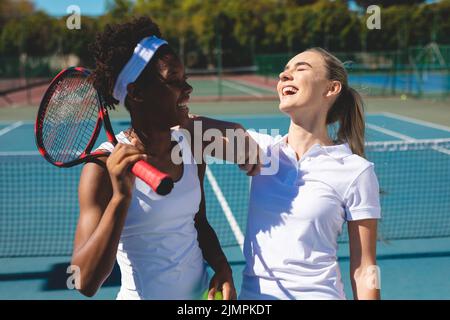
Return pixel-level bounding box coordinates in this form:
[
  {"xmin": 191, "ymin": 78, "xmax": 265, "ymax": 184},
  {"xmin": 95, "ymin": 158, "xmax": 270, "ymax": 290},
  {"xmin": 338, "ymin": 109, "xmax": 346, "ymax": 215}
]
[{"xmin": 131, "ymin": 160, "xmax": 173, "ymax": 196}]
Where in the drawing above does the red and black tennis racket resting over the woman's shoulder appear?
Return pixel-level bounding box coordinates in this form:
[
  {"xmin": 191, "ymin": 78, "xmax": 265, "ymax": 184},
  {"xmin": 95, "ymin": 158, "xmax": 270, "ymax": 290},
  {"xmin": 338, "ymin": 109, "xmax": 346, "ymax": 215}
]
[{"xmin": 35, "ymin": 67, "xmax": 173, "ymax": 195}]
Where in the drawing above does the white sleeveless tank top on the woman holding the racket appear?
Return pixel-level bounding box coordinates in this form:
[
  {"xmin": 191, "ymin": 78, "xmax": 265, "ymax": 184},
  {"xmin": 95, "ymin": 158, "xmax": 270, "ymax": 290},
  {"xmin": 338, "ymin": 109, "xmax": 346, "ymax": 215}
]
[{"xmin": 99, "ymin": 130, "xmax": 208, "ymax": 300}]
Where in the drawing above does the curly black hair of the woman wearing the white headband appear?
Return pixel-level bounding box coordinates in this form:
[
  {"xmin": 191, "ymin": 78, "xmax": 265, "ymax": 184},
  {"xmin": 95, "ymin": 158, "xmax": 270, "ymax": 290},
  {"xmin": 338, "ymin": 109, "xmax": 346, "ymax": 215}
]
[{"xmin": 90, "ymin": 17, "xmax": 166, "ymax": 109}]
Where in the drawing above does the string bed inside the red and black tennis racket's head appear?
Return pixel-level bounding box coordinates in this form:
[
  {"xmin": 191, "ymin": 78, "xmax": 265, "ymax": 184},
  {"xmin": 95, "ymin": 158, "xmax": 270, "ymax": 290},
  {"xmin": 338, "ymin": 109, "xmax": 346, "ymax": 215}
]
[{"xmin": 42, "ymin": 74, "xmax": 99, "ymax": 163}]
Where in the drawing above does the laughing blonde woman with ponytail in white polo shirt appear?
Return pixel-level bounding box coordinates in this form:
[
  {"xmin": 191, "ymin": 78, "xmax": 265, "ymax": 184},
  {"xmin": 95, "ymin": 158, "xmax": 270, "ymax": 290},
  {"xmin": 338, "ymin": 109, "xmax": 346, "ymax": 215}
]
[{"xmin": 239, "ymin": 48, "xmax": 381, "ymax": 299}]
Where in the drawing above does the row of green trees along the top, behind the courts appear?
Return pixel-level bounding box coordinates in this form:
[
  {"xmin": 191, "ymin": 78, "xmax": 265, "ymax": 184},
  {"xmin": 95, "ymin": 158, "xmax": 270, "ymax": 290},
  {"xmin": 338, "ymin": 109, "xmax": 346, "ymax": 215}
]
[{"xmin": 0, "ymin": 0, "xmax": 450, "ymax": 67}]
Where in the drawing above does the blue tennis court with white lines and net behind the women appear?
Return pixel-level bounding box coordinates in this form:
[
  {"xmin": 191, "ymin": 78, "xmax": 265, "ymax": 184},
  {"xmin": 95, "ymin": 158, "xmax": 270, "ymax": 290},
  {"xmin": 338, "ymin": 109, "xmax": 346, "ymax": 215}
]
[{"xmin": 0, "ymin": 113, "xmax": 450, "ymax": 299}]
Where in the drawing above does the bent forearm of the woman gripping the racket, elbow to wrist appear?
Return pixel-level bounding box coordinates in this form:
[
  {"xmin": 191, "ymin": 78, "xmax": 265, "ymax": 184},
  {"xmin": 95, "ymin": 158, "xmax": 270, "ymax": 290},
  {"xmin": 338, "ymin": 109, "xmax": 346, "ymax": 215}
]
[{"xmin": 72, "ymin": 197, "xmax": 130, "ymax": 296}]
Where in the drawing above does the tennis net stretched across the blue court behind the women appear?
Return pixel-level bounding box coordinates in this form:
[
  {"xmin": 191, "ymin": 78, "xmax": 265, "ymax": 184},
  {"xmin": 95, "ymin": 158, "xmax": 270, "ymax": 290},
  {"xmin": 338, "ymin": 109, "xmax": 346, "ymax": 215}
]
[{"xmin": 0, "ymin": 139, "xmax": 450, "ymax": 257}]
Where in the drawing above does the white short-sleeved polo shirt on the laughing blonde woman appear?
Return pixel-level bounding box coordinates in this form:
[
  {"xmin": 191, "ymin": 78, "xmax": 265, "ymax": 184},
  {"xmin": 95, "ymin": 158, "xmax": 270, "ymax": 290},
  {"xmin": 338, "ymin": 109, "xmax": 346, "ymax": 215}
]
[{"xmin": 239, "ymin": 131, "xmax": 381, "ymax": 299}]
